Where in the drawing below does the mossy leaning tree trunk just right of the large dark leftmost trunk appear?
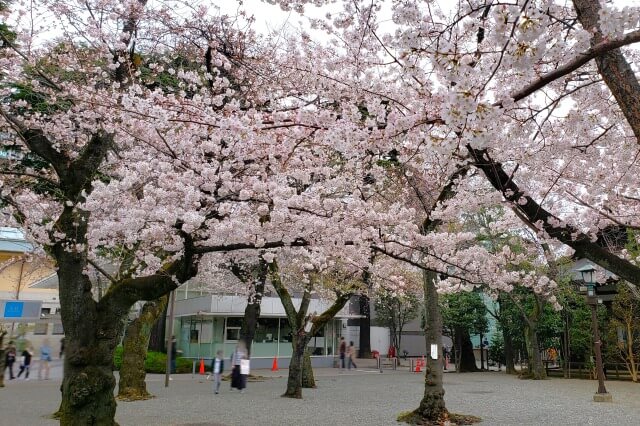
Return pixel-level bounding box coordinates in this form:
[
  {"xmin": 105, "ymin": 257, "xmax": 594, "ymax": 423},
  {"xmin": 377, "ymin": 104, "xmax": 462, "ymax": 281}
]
[{"xmin": 118, "ymin": 296, "xmax": 168, "ymax": 401}]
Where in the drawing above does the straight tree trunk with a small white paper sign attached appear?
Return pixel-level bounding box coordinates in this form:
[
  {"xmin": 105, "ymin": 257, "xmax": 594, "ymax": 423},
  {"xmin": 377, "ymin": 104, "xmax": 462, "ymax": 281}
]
[{"xmin": 413, "ymin": 271, "xmax": 449, "ymax": 423}]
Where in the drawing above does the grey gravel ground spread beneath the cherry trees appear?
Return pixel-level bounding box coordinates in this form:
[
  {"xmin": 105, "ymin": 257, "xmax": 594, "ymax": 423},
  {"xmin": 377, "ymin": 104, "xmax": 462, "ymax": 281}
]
[{"xmin": 0, "ymin": 369, "xmax": 640, "ymax": 426}]
